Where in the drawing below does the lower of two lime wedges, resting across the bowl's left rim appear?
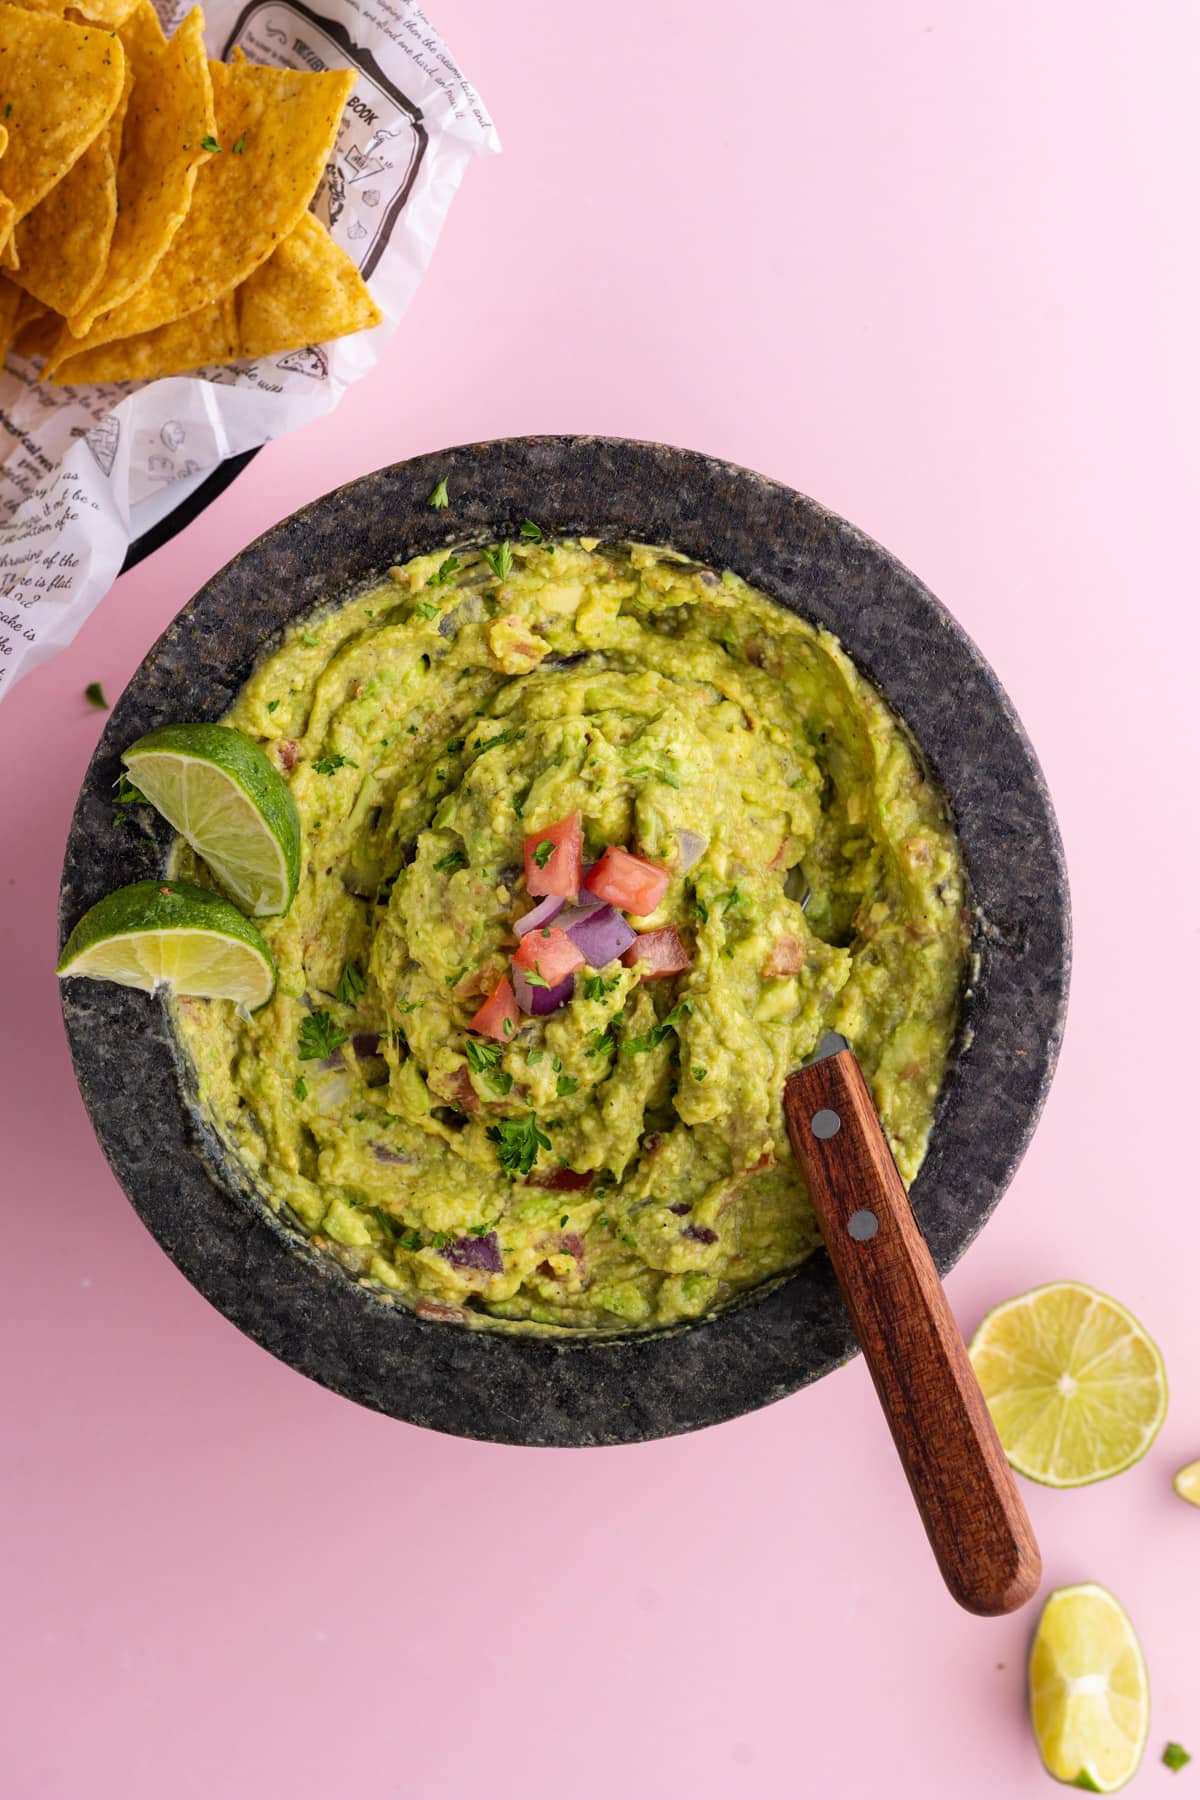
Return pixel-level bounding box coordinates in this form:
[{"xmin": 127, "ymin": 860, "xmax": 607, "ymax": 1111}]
[{"xmin": 58, "ymin": 882, "xmax": 275, "ymax": 1010}]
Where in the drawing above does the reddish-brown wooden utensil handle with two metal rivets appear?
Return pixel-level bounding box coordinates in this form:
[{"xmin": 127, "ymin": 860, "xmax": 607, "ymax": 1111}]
[{"xmin": 784, "ymin": 1049, "xmax": 1042, "ymax": 1615}]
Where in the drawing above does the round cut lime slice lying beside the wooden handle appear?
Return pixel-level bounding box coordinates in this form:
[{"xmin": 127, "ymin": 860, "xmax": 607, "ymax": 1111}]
[{"xmin": 972, "ymin": 1282, "xmax": 1166, "ymax": 1487}]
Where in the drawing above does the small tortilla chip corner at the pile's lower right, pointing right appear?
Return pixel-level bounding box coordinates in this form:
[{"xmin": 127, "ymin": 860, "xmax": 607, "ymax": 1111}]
[{"xmin": 237, "ymin": 212, "xmax": 383, "ymax": 356}]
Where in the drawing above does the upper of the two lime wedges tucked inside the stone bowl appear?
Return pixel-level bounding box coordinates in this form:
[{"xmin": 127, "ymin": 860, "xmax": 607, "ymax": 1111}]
[{"xmin": 122, "ymin": 725, "xmax": 300, "ymax": 918}]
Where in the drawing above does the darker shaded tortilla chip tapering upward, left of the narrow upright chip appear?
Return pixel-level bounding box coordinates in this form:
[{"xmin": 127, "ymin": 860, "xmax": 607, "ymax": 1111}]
[{"xmin": 13, "ymin": 53, "xmax": 133, "ymax": 315}]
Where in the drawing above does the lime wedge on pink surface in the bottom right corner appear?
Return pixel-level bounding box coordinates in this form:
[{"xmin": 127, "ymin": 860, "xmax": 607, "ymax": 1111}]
[{"xmin": 1029, "ymin": 1582, "xmax": 1150, "ymax": 1795}]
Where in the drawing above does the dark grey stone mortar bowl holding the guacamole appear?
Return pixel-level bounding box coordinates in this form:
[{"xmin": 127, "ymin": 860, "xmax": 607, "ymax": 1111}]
[{"xmin": 59, "ymin": 437, "xmax": 1070, "ymax": 1445}]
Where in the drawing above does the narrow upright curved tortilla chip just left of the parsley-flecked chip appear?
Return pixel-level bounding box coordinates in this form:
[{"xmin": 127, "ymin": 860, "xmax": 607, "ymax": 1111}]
[{"xmin": 67, "ymin": 0, "xmax": 216, "ymax": 338}]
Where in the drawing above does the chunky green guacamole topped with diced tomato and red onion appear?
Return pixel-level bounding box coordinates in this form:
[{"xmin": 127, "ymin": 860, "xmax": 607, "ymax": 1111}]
[{"xmin": 175, "ymin": 527, "xmax": 970, "ymax": 1332}]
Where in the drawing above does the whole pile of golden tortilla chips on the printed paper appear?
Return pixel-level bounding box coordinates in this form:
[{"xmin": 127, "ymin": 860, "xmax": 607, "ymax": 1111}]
[{"xmin": 0, "ymin": 0, "xmax": 381, "ymax": 385}]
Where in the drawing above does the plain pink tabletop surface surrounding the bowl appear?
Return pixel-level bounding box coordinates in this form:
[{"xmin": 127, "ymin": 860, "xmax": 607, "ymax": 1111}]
[{"xmin": 0, "ymin": 0, "xmax": 1200, "ymax": 1800}]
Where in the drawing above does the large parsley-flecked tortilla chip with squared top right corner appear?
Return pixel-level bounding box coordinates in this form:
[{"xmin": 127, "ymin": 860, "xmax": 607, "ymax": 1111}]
[{"xmin": 58, "ymin": 63, "xmax": 354, "ymax": 362}]
